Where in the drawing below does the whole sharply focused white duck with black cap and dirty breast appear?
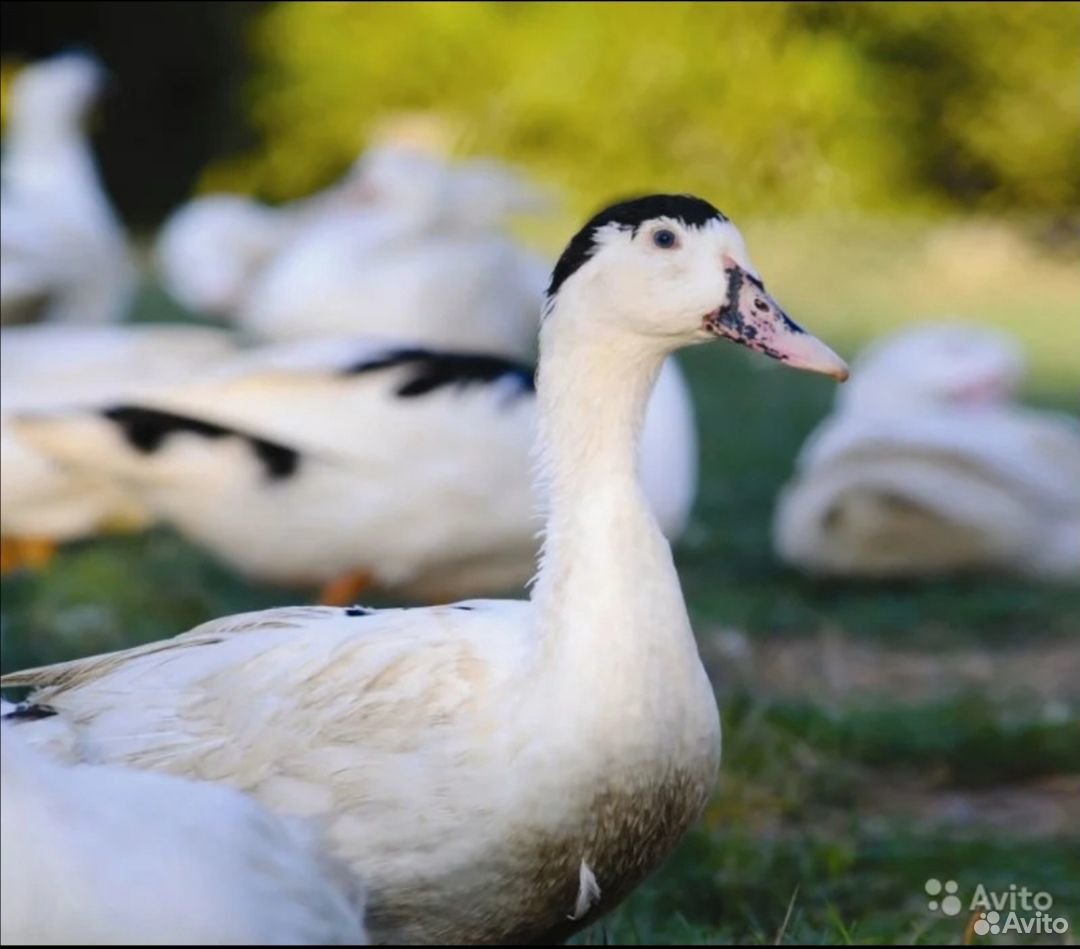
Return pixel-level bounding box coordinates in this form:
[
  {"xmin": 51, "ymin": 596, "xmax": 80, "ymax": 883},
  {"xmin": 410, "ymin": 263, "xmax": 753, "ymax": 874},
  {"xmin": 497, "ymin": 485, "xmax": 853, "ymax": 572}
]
[{"xmin": 0, "ymin": 195, "xmax": 846, "ymax": 945}]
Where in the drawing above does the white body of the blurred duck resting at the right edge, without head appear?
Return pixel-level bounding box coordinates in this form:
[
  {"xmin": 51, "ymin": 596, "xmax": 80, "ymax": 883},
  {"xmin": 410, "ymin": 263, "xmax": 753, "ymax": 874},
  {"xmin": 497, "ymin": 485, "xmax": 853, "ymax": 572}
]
[{"xmin": 775, "ymin": 407, "xmax": 1080, "ymax": 582}]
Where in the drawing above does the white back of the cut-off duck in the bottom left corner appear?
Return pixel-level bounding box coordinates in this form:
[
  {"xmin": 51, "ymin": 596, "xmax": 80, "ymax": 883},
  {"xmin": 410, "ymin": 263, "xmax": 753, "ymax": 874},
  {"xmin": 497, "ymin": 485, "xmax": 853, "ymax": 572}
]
[{"xmin": 0, "ymin": 725, "xmax": 366, "ymax": 946}]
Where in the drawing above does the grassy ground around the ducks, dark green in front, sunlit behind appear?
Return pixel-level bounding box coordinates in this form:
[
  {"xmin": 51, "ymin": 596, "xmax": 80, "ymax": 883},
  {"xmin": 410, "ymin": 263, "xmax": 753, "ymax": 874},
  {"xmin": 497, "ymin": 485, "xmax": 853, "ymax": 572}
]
[{"xmin": 0, "ymin": 221, "xmax": 1080, "ymax": 945}]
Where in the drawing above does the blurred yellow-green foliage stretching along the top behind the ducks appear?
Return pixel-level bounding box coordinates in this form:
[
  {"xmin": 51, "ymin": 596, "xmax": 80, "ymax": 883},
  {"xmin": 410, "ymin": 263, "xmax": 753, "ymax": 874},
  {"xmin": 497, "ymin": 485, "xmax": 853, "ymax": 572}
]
[{"xmin": 205, "ymin": 2, "xmax": 1080, "ymax": 216}]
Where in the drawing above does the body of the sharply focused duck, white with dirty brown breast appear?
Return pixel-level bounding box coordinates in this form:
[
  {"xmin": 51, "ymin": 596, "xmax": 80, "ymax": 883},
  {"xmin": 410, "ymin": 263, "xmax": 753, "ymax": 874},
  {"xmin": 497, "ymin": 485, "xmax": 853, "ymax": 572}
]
[{"xmin": 6, "ymin": 601, "xmax": 718, "ymax": 944}]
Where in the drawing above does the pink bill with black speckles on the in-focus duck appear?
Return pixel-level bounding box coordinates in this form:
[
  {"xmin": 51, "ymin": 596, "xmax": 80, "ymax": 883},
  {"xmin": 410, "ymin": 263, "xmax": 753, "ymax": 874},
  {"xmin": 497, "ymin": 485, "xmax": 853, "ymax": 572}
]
[{"xmin": 705, "ymin": 267, "xmax": 848, "ymax": 382}]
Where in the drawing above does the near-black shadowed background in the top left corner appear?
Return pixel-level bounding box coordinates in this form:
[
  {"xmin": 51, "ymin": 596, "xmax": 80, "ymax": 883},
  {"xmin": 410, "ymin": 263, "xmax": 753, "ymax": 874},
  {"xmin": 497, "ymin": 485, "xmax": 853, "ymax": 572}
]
[{"xmin": 0, "ymin": 0, "xmax": 265, "ymax": 225}]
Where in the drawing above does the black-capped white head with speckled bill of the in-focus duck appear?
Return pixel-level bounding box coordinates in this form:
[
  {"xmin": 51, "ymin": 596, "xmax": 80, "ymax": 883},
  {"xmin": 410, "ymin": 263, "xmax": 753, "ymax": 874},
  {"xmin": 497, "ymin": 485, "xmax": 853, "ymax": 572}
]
[{"xmin": 545, "ymin": 194, "xmax": 848, "ymax": 381}]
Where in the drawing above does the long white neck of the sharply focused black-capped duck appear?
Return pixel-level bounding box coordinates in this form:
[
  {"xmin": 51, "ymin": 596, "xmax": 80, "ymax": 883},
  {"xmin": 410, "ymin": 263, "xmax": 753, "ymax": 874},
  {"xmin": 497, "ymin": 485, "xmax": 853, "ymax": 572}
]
[{"xmin": 532, "ymin": 304, "xmax": 701, "ymax": 708}]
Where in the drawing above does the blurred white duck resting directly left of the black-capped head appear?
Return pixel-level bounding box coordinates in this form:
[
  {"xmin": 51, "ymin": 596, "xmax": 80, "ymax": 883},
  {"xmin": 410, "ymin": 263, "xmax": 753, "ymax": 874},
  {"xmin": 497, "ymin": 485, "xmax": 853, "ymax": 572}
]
[{"xmin": 237, "ymin": 147, "xmax": 546, "ymax": 355}]
